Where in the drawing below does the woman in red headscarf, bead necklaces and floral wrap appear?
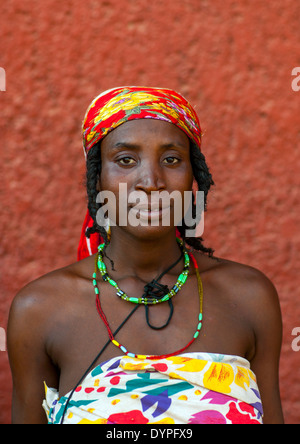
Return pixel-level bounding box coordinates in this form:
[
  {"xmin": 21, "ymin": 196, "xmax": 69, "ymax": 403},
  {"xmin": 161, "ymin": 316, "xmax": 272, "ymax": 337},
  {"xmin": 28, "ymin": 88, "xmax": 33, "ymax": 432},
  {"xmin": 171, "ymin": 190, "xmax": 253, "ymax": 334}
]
[{"xmin": 9, "ymin": 87, "xmax": 283, "ymax": 424}]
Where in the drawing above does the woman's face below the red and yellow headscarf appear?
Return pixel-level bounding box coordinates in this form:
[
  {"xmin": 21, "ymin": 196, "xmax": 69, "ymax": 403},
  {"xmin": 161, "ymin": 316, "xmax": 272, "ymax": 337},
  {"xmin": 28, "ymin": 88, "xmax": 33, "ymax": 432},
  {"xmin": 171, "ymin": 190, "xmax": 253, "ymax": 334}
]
[{"xmin": 99, "ymin": 119, "xmax": 193, "ymax": 236}]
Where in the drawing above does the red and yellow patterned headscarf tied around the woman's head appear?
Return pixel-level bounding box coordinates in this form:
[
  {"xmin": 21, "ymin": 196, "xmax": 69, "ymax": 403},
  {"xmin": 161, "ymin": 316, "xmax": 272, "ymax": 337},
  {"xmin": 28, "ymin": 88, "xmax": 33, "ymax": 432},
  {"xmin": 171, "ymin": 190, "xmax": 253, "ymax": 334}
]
[{"xmin": 78, "ymin": 86, "xmax": 202, "ymax": 260}]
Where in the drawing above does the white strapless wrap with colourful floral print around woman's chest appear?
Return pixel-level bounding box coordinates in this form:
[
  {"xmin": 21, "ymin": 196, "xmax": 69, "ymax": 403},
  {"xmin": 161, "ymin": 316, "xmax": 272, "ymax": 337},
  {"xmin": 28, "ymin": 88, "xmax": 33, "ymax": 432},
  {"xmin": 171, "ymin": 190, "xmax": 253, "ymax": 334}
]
[{"xmin": 43, "ymin": 353, "xmax": 263, "ymax": 424}]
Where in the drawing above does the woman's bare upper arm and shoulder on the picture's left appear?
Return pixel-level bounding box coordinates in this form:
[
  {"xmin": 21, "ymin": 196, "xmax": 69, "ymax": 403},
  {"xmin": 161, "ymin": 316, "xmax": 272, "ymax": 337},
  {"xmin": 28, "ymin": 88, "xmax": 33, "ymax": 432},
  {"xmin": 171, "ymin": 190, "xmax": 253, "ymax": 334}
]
[{"xmin": 8, "ymin": 286, "xmax": 58, "ymax": 424}]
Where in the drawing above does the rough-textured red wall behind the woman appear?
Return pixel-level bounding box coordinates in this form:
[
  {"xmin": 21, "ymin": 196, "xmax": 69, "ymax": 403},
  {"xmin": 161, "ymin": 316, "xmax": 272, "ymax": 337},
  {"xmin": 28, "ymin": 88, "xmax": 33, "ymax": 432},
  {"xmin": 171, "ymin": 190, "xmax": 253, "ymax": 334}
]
[{"xmin": 0, "ymin": 0, "xmax": 300, "ymax": 423}]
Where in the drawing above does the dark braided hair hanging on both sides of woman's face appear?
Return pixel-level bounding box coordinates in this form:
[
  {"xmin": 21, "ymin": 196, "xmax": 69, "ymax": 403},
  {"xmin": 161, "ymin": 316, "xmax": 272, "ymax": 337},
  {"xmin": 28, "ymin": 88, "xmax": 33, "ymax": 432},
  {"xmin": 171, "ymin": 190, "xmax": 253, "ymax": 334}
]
[{"xmin": 86, "ymin": 141, "xmax": 214, "ymax": 257}]
